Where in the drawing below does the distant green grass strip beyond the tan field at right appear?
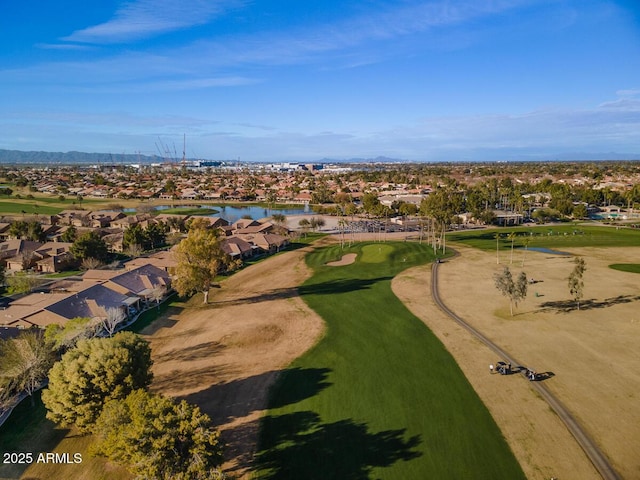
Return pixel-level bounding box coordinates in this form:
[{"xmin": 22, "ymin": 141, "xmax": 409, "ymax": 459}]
[{"xmin": 447, "ymin": 225, "xmax": 640, "ymax": 251}]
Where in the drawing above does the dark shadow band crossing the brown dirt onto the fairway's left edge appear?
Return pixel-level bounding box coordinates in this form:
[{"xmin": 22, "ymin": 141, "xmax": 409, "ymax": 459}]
[{"xmin": 183, "ymin": 368, "xmax": 331, "ymax": 425}]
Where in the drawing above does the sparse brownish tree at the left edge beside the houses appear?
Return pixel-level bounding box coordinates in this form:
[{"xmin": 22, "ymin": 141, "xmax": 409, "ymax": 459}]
[{"xmin": 0, "ymin": 330, "xmax": 54, "ymax": 405}]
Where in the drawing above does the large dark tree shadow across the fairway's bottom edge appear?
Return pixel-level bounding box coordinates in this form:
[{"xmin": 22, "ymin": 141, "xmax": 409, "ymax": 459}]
[{"xmin": 256, "ymin": 411, "xmax": 422, "ymax": 480}]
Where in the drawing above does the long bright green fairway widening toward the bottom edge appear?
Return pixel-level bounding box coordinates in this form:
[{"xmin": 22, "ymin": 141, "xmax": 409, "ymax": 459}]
[{"xmin": 256, "ymin": 242, "xmax": 524, "ymax": 480}]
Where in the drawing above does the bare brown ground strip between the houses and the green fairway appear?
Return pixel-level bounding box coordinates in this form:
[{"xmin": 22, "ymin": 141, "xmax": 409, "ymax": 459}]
[{"xmin": 138, "ymin": 250, "xmax": 324, "ymax": 478}]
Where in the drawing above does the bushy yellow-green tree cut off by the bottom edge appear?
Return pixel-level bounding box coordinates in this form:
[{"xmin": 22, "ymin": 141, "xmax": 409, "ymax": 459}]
[{"xmin": 92, "ymin": 390, "xmax": 224, "ymax": 480}]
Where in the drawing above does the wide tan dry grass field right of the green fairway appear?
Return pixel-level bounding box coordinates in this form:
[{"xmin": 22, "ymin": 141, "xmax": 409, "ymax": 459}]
[{"xmin": 393, "ymin": 248, "xmax": 640, "ymax": 479}]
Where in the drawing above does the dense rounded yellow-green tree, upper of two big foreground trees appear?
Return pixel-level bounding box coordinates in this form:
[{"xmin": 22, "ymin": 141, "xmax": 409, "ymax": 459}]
[{"xmin": 42, "ymin": 332, "xmax": 152, "ymax": 432}]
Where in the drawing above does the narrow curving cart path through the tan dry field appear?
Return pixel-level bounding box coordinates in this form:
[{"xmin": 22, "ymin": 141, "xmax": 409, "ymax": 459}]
[{"xmin": 431, "ymin": 263, "xmax": 620, "ymax": 480}]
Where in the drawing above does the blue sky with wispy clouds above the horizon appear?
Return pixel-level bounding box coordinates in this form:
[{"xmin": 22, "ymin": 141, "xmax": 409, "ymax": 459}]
[{"xmin": 0, "ymin": 0, "xmax": 640, "ymax": 162}]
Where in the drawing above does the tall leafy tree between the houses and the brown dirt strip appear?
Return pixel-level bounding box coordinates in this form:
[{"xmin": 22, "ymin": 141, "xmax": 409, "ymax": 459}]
[{"xmin": 173, "ymin": 220, "xmax": 238, "ymax": 304}]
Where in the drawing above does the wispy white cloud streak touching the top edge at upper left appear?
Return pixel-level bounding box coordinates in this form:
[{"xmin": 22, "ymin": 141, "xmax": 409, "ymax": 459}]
[{"xmin": 62, "ymin": 0, "xmax": 246, "ymax": 44}]
